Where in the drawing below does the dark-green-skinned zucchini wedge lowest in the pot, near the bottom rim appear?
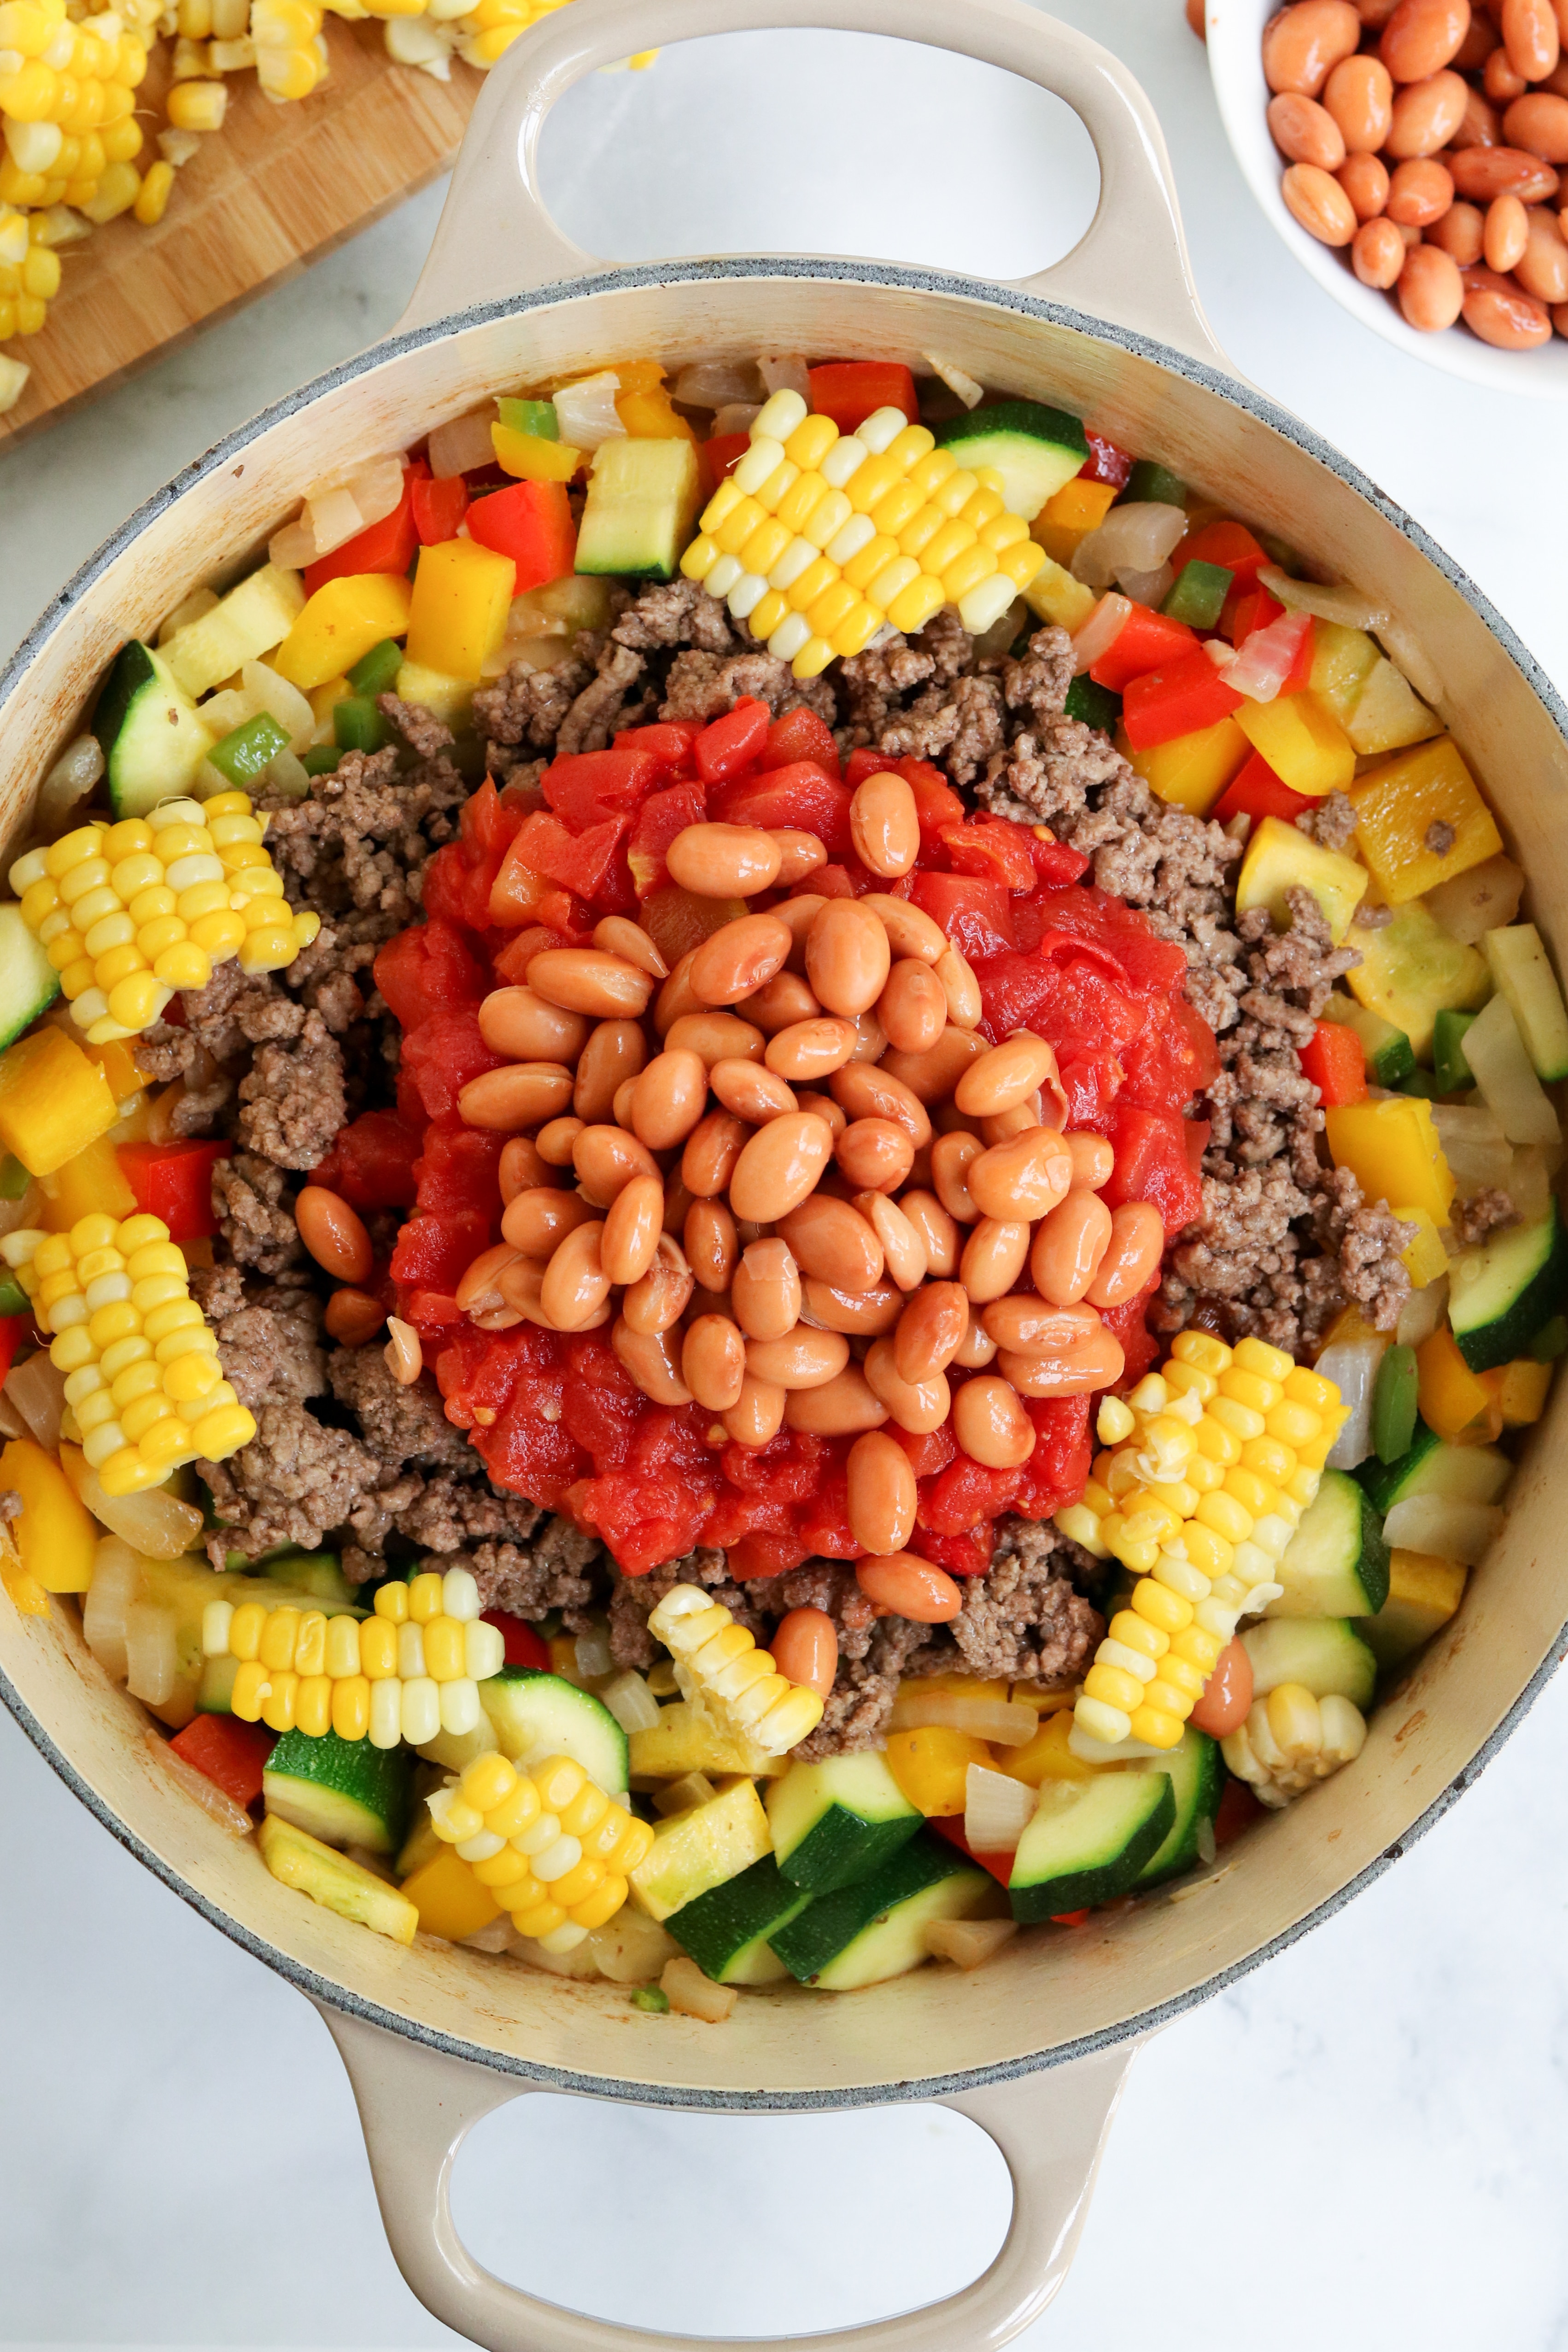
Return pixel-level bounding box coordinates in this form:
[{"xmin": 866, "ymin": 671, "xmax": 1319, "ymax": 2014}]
[{"xmin": 773, "ymin": 1837, "xmax": 1001, "ymax": 1992}]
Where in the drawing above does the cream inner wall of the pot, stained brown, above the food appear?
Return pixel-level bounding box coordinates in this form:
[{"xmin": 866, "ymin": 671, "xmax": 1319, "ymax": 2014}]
[{"xmin": 0, "ymin": 263, "xmax": 1568, "ymax": 2105}]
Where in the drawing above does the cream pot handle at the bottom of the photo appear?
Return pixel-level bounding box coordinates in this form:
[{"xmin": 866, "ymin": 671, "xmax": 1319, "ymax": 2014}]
[{"xmin": 317, "ymin": 2001, "xmax": 1135, "ymax": 2352}]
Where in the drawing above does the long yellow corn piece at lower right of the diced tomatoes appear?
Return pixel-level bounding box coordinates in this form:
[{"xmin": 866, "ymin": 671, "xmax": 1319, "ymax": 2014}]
[{"xmin": 1055, "ymin": 1331, "xmax": 1345, "ymax": 1757}]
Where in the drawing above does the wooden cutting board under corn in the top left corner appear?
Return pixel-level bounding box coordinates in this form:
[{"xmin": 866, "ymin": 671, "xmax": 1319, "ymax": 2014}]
[{"xmin": 0, "ymin": 17, "xmax": 482, "ymax": 447}]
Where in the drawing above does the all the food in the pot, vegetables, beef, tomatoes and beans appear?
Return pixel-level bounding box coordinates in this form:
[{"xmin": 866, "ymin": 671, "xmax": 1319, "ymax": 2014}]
[{"xmin": 0, "ymin": 355, "xmax": 1568, "ymax": 2020}]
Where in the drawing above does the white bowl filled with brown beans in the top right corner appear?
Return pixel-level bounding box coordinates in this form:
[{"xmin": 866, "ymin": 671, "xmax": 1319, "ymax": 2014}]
[{"xmin": 1206, "ymin": 0, "xmax": 1568, "ymax": 400}]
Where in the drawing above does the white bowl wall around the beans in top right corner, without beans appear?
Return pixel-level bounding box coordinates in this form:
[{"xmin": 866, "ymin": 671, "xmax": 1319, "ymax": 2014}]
[{"xmin": 1208, "ymin": 0, "xmax": 1568, "ymax": 400}]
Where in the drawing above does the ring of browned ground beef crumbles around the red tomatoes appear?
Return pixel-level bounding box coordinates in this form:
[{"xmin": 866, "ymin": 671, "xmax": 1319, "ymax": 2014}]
[{"xmin": 162, "ymin": 597, "xmax": 1420, "ymax": 1759}]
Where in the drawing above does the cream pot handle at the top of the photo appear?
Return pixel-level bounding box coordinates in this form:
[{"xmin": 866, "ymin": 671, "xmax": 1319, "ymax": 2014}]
[{"xmin": 400, "ymin": 0, "xmax": 1229, "ymax": 369}]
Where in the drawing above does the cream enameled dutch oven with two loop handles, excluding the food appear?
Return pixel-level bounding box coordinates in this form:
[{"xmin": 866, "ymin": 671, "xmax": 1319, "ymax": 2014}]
[{"xmin": 0, "ymin": 0, "xmax": 1568, "ymax": 2352}]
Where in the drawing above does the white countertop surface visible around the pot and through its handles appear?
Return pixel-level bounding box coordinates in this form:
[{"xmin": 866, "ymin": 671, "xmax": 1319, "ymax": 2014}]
[{"xmin": 0, "ymin": 0, "xmax": 1568, "ymax": 2352}]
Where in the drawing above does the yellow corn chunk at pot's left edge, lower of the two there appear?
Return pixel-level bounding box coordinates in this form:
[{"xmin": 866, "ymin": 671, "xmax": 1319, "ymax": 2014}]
[{"xmin": 0, "ymin": 1211, "xmax": 256, "ymax": 1493}]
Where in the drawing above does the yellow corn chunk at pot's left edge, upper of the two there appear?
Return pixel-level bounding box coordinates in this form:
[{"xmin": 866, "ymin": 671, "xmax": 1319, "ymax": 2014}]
[{"xmin": 9, "ymin": 793, "xmax": 322, "ymax": 1044}]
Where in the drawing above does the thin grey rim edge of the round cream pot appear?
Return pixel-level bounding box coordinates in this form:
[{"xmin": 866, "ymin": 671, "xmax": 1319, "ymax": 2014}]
[{"xmin": 12, "ymin": 257, "xmax": 1568, "ymax": 2114}]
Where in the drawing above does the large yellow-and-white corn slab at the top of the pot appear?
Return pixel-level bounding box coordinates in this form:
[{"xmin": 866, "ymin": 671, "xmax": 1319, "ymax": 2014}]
[{"xmin": 682, "ymin": 393, "xmax": 1044, "ymax": 678}]
